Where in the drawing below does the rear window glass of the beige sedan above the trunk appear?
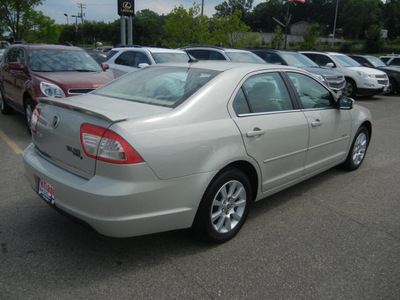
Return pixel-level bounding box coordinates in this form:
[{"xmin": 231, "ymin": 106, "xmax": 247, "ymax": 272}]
[{"xmin": 94, "ymin": 67, "xmax": 220, "ymax": 107}]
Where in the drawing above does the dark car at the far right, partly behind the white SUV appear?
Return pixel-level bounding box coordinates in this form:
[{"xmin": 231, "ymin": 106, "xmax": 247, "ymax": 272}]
[{"xmin": 349, "ymin": 54, "xmax": 400, "ymax": 94}]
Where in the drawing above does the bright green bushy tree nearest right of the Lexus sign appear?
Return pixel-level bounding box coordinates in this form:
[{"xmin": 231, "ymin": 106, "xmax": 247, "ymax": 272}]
[{"xmin": 164, "ymin": 4, "xmax": 210, "ymax": 47}]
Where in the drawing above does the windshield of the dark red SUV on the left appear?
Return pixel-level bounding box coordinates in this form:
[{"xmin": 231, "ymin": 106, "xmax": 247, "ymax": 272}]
[{"xmin": 29, "ymin": 49, "xmax": 102, "ymax": 72}]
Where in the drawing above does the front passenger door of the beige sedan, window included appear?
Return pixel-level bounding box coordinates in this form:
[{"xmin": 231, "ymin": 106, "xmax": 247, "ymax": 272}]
[{"xmin": 287, "ymin": 72, "xmax": 351, "ymax": 174}]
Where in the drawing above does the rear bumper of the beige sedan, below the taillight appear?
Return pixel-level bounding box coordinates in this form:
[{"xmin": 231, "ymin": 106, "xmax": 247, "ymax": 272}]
[{"xmin": 23, "ymin": 144, "xmax": 214, "ymax": 237}]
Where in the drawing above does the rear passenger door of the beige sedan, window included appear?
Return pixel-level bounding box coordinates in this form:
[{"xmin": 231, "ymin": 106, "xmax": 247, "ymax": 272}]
[{"xmin": 233, "ymin": 72, "xmax": 309, "ymax": 192}]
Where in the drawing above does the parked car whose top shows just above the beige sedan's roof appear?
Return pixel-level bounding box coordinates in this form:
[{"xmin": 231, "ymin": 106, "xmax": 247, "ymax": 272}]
[{"xmin": 181, "ymin": 47, "xmax": 265, "ymax": 63}]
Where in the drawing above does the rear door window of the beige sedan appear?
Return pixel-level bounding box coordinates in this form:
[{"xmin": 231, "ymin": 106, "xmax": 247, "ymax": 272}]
[{"xmin": 235, "ymin": 72, "xmax": 293, "ymax": 113}]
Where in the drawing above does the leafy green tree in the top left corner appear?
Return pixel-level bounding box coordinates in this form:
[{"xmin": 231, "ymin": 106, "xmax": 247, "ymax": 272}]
[{"xmin": 0, "ymin": 0, "xmax": 44, "ymax": 40}]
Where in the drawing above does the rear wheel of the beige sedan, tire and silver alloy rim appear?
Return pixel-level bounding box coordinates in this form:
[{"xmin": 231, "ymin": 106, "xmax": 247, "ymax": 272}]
[{"xmin": 192, "ymin": 168, "xmax": 252, "ymax": 243}]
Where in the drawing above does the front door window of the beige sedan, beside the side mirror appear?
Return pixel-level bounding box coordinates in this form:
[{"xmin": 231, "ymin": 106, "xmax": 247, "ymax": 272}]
[{"xmin": 288, "ymin": 72, "xmax": 334, "ymax": 109}]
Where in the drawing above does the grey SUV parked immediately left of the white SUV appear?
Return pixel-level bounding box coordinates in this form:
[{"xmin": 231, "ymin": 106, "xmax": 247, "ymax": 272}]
[{"xmin": 251, "ymin": 50, "xmax": 346, "ymax": 94}]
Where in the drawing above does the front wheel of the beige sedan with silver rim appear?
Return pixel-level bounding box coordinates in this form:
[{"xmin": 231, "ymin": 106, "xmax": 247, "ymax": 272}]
[{"xmin": 343, "ymin": 126, "xmax": 369, "ymax": 171}]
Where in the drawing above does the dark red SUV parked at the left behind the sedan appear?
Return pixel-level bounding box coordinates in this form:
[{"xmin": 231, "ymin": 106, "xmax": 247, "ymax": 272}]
[{"xmin": 0, "ymin": 43, "xmax": 114, "ymax": 131}]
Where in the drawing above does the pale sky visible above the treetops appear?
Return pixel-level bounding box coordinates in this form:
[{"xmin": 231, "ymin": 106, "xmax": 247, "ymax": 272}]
[{"xmin": 35, "ymin": 0, "xmax": 262, "ymax": 24}]
